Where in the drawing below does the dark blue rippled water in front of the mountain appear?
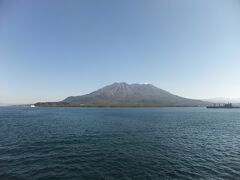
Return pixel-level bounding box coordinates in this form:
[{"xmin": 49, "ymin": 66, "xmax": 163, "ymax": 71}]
[{"xmin": 0, "ymin": 108, "xmax": 240, "ymax": 180}]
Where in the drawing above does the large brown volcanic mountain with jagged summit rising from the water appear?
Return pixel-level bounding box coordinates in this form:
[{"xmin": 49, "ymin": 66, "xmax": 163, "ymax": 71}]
[{"xmin": 35, "ymin": 83, "xmax": 209, "ymax": 107}]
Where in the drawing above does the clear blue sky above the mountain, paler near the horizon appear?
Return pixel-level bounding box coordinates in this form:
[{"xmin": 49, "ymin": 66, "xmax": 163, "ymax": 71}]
[{"xmin": 0, "ymin": 0, "xmax": 240, "ymax": 103}]
